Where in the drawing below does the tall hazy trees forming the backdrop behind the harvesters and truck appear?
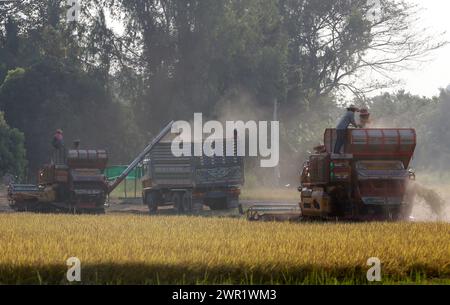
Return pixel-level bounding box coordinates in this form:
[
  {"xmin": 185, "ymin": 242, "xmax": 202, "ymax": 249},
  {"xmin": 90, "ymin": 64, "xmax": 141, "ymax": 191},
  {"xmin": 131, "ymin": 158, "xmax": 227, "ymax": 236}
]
[{"xmin": 0, "ymin": 0, "xmax": 444, "ymax": 180}]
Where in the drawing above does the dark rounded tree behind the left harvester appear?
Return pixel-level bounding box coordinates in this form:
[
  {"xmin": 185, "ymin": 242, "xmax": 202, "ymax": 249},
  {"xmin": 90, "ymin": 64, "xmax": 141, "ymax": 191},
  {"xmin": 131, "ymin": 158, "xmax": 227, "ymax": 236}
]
[{"xmin": 0, "ymin": 61, "xmax": 141, "ymax": 172}]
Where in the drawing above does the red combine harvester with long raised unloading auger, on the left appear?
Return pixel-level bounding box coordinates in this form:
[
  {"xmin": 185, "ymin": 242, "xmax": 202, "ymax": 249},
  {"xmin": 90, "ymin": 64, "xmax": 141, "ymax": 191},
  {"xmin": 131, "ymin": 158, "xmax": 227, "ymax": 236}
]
[{"xmin": 8, "ymin": 121, "xmax": 173, "ymax": 213}]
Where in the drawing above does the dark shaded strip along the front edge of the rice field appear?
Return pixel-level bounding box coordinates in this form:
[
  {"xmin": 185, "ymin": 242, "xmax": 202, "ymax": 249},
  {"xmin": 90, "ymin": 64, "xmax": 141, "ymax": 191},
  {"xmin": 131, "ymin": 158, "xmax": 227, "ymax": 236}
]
[{"xmin": 0, "ymin": 263, "xmax": 450, "ymax": 285}]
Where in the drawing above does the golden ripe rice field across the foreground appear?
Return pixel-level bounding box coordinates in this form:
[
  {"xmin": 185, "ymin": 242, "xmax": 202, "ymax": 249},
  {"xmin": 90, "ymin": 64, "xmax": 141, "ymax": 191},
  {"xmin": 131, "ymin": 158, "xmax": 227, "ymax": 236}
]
[{"xmin": 0, "ymin": 214, "xmax": 450, "ymax": 284}]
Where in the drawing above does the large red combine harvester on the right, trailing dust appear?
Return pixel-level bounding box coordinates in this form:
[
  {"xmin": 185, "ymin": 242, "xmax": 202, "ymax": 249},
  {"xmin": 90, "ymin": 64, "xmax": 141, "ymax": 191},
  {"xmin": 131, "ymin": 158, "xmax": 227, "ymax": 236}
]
[{"xmin": 298, "ymin": 128, "xmax": 416, "ymax": 221}]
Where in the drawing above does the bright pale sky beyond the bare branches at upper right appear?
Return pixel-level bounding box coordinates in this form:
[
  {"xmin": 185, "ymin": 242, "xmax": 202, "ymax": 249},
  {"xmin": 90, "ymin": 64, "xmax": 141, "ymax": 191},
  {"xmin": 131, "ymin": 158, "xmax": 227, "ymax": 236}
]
[{"xmin": 386, "ymin": 0, "xmax": 450, "ymax": 96}]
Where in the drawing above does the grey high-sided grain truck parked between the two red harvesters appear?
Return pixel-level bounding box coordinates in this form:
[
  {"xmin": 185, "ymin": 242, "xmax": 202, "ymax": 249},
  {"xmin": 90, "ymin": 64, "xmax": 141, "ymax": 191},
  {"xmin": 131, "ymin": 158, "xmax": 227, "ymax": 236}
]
[{"xmin": 142, "ymin": 139, "xmax": 244, "ymax": 213}]
